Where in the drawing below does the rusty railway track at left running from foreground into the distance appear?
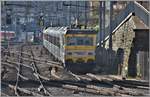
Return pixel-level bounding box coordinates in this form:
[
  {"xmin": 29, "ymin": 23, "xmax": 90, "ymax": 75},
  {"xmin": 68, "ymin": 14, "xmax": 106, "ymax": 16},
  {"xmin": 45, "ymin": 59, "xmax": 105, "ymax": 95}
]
[{"xmin": 2, "ymin": 45, "xmax": 54, "ymax": 96}]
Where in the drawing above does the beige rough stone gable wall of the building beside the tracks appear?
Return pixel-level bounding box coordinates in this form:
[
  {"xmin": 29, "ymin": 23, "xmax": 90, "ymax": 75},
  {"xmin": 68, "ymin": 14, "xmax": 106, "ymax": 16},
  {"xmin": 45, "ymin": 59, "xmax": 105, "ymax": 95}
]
[{"xmin": 105, "ymin": 17, "xmax": 135, "ymax": 74}]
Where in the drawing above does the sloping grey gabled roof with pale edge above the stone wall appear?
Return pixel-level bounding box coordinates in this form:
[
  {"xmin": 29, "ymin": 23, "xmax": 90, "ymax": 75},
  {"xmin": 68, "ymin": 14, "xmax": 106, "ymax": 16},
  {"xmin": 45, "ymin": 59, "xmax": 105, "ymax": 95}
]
[{"xmin": 103, "ymin": 1, "xmax": 150, "ymax": 42}]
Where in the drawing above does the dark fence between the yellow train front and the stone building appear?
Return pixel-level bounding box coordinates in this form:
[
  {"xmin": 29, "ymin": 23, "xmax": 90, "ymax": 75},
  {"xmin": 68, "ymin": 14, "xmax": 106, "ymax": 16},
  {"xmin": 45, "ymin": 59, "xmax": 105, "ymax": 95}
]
[{"xmin": 96, "ymin": 47, "xmax": 119, "ymax": 74}]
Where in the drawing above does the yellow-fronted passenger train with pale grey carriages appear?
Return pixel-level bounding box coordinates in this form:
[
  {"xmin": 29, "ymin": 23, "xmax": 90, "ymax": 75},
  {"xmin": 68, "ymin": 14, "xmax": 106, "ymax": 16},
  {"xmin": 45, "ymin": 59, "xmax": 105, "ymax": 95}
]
[{"xmin": 43, "ymin": 27, "xmax": 97, "ymax": 74}]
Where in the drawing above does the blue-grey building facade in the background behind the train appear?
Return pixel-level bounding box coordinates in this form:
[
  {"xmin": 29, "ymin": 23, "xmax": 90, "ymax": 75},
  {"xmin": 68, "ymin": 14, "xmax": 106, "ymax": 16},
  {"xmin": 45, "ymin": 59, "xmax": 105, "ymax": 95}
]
[{"xmin": 1, "ymin": 1, "xmax": 90, "ymax": 41}]
